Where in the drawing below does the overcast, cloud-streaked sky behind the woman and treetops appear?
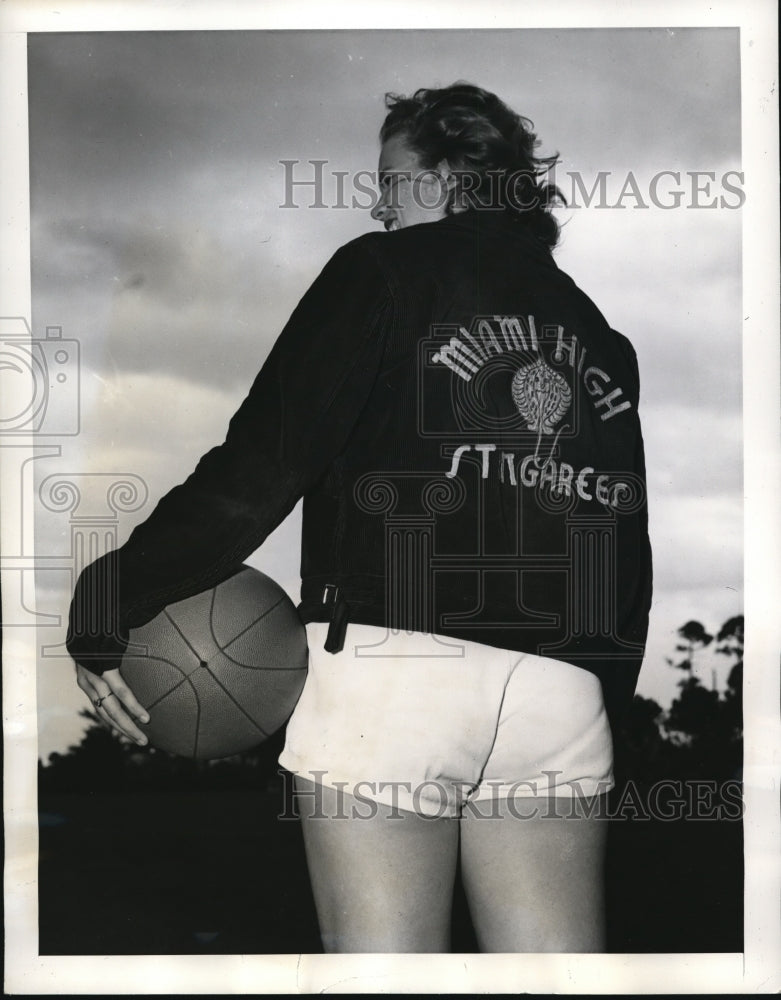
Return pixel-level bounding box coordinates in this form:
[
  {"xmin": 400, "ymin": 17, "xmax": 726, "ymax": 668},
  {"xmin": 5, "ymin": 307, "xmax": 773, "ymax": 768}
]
[{"xmin": 28, "ymin": 29, "xmax": 743, "ymax": 756}]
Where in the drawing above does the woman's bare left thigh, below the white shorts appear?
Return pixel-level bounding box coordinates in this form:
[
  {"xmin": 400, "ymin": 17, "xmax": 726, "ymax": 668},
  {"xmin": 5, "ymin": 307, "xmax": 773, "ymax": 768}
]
[{"xmin": 295, "ymin": 777, "xmax": 458, "ymax": 952}]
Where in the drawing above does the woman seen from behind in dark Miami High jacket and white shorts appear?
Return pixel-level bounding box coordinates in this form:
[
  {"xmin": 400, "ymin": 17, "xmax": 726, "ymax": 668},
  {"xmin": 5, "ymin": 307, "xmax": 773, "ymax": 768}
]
[{"xmin": 69, "ymin": 84, "xmax": 651, "ymax": 952}]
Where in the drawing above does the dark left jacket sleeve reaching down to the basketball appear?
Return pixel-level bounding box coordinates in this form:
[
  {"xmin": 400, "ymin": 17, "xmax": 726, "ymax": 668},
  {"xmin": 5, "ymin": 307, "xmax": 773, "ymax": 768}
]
[{"xmin": 66, "ymin": 240, "xmax": 392, "ymax": 673}]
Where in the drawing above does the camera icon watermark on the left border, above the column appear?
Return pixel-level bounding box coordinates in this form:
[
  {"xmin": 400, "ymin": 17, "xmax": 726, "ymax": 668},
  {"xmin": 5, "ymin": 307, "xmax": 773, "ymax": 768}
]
[{"xmin": 0, "ymin": 316, "xmax": 80, "ymax": 437}]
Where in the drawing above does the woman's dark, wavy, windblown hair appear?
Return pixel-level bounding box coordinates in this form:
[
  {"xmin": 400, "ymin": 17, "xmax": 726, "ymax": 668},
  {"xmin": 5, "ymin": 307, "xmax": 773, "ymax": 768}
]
[{"xmin": 380, "ymin": 81, "xmax": 566, "ymax": 247}]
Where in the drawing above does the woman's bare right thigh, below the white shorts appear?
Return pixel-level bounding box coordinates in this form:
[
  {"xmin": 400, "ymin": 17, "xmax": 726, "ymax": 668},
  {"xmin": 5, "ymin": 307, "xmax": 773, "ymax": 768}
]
[{"xmin": 461, "ymin": 798, "xmax": 607, "ymax": 952}]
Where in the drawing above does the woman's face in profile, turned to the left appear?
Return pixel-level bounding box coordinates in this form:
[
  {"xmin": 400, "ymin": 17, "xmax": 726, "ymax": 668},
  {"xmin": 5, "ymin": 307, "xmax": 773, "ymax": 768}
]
[{"xmin": 371, "ymin": 134, "xmax": 449, "ymax": 231}]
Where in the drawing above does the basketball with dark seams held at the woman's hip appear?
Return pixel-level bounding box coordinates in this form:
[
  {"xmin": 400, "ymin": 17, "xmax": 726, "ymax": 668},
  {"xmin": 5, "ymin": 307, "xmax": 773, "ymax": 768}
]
[{"xmin": 120, "ymin": 566, "xmax": 307, "ymax": 760}]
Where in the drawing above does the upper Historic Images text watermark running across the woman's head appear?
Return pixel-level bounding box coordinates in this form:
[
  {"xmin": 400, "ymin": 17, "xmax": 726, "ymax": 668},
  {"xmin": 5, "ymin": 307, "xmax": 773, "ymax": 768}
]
[{"xmin": 279, "ymin": 159, "xmax": 746, "ymax": 211}]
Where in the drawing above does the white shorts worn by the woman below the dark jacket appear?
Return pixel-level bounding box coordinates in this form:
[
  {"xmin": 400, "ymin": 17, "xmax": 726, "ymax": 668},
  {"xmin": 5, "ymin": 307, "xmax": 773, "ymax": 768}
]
[{"xmin": 279, "ymin": 622, "xmax": 613, "ymax": 816}]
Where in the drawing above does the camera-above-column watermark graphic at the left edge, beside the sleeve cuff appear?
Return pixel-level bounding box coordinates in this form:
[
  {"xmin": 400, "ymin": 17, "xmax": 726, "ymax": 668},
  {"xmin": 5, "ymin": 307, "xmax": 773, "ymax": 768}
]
[{"xmin": 0, "ymin": 316, "xmax": 149, "ymax": 658}]
